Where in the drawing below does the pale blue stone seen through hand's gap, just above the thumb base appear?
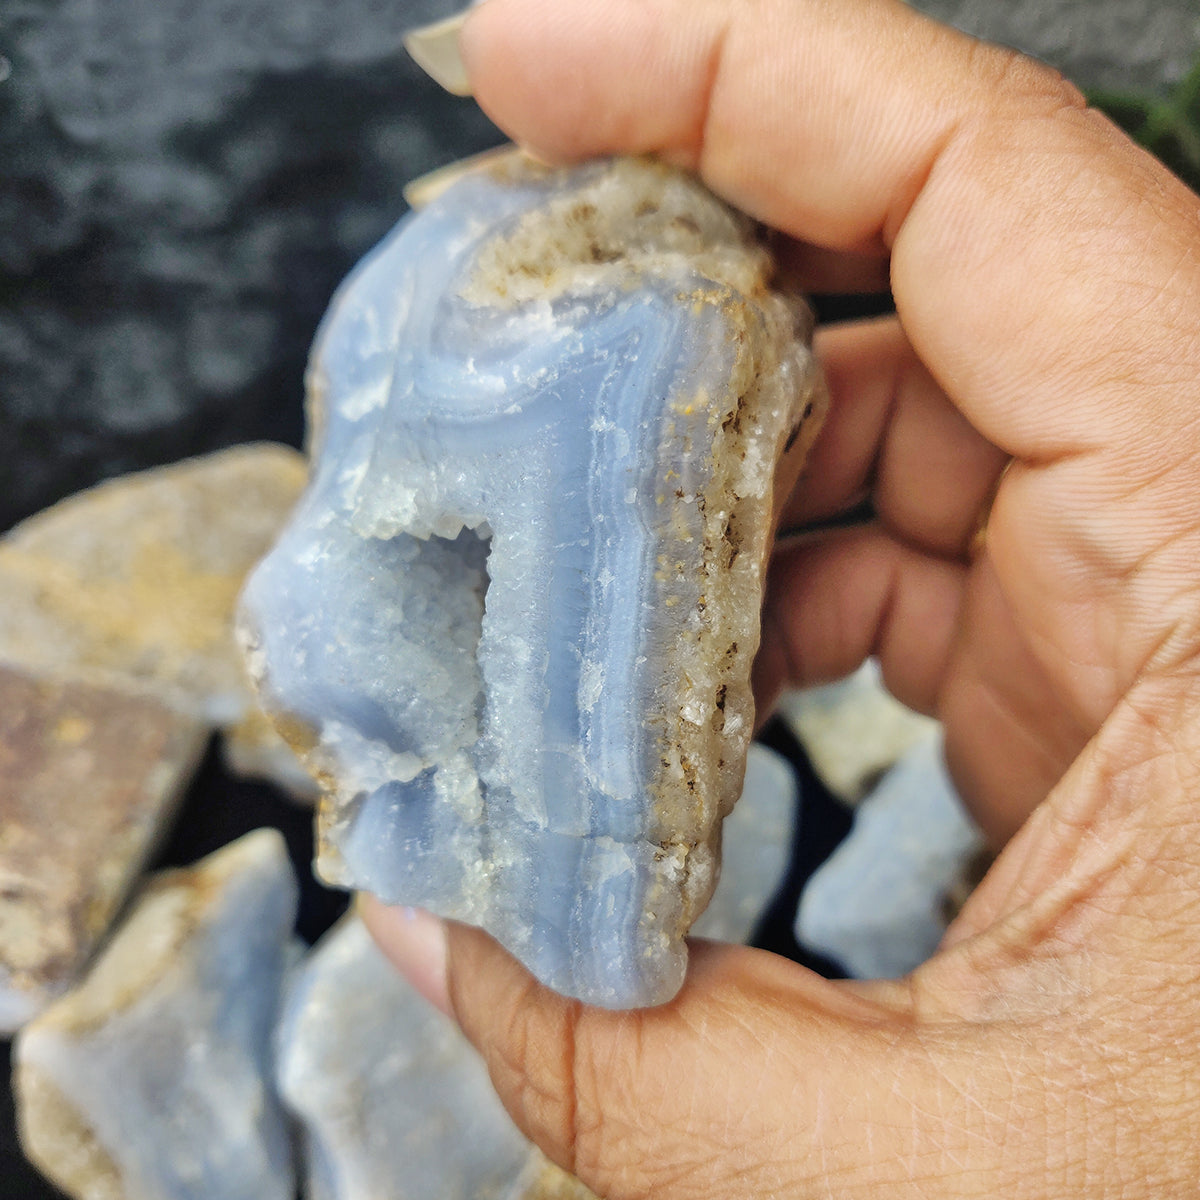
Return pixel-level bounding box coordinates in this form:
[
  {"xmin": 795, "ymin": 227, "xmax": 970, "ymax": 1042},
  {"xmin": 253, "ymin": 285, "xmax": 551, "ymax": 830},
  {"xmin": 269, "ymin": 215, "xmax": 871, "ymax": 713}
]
[{"xmin": 796, "ymin": 734, "xmax": 983, "ymax": 979}]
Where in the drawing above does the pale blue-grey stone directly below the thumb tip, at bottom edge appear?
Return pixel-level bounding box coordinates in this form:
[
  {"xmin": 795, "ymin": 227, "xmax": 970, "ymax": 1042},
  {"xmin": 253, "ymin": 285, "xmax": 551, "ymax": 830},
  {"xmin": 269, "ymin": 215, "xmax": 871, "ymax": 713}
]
[{"xmin": 277, "ymin": 914, "xmax": 564, "ymax": 1200}]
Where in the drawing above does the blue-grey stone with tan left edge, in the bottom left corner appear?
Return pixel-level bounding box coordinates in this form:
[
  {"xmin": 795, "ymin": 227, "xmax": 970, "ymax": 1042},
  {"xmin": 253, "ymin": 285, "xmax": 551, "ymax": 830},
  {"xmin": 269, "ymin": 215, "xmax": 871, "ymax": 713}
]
[{"xmin": 14, "ymin": 830, "xmax": 296, "ymax": 1200}]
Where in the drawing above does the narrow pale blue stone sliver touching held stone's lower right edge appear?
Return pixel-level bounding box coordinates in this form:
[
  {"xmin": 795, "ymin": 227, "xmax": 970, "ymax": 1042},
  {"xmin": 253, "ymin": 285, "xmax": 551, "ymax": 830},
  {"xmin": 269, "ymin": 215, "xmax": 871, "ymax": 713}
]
[{"xmin": 691, "ymin": 742, "xmax": 799, "ymax": 942}]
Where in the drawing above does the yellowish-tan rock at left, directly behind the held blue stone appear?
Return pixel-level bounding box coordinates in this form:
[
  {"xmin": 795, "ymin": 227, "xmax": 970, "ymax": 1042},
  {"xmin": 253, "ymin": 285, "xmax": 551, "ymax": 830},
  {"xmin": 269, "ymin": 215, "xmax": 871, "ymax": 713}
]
[{"xmin": 0, "ymin": 444, "xmax": 312, "ymax": 793}]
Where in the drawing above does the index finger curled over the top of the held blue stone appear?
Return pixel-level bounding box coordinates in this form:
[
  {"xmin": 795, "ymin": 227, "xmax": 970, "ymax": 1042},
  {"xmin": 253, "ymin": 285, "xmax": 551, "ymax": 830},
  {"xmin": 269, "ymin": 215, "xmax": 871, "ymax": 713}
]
[{"xmin": 461, "ymin": 0, "xmax": 1200, "ymax": 462}]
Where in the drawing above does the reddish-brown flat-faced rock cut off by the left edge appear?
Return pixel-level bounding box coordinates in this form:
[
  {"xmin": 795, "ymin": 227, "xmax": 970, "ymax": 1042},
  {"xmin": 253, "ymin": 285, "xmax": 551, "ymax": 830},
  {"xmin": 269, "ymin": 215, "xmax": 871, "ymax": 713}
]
[{"xmin": 0, "ymin": 667, "xmax": 208, "ymax": 1032}]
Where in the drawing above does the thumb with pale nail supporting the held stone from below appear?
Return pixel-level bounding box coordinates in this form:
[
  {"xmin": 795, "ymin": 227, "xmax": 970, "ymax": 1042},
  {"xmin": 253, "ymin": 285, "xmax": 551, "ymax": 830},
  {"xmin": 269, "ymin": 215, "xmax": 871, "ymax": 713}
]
[{"xmin": 362, "ymin": 901, "xmax": 1036, "ymax": 1200}]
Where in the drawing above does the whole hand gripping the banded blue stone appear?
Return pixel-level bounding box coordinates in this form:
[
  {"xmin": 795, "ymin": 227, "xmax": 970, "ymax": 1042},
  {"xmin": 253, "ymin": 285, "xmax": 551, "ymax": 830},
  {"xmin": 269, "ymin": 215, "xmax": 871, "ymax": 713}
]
[{"xmin": 366, "ymin": 0, "xmax": 1200, "ymax": 1200}]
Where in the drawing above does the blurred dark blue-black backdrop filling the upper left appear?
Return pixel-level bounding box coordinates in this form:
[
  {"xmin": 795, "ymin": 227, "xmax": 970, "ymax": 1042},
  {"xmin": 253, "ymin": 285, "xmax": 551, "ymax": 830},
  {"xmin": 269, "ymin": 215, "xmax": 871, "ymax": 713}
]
[{"xmin": 0, "ymin": 0, "xmax": 498, "ymax": 529}]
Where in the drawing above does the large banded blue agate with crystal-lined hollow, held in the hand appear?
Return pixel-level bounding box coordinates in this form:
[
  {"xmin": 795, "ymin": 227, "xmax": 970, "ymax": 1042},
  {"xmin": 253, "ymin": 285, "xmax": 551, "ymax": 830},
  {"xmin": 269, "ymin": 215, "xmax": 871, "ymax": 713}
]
[{"xmin": 242, "ymin": 156, "xmax": 824, "ymax": 1007}]
